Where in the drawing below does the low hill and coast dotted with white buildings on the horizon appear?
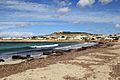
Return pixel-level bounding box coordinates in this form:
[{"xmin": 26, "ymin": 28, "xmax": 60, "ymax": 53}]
[{"xmin": 0, "ymin": 31, "xmax": 120, "ymax": 42}]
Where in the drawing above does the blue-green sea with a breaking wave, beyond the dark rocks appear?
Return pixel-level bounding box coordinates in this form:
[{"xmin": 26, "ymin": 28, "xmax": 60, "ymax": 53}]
[{"xmin": 0, "ymin": 42, "xmax": 79, "ymax": 58}]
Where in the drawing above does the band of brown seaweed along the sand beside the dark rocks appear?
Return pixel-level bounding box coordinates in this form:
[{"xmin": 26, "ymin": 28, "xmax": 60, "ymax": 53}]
[{"xmin": 0, "ymin": 45, "xmax": 107, "ymax": 78}]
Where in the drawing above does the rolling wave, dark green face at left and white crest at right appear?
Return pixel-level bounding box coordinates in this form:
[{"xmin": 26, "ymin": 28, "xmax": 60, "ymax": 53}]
[{"xmin": 0, "ymin": 44, "xmax": 59, "ymax": 55}]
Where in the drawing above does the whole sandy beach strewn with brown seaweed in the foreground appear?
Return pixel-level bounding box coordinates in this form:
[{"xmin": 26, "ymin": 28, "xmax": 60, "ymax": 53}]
[{"xmin": 0, "ymin": 45, "xmax": 120, "ymax": 80}]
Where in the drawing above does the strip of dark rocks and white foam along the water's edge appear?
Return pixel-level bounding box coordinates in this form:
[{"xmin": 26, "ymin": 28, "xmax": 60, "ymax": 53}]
[{"xmin": 0, "ymin": 42, "xmax": 98, "ymax": 62}]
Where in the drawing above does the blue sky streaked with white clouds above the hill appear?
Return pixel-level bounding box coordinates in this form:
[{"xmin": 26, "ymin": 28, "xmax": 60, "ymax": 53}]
[{"xmin": 0, "ymin": 0, "xmax": 120, "ymax": 37}]
